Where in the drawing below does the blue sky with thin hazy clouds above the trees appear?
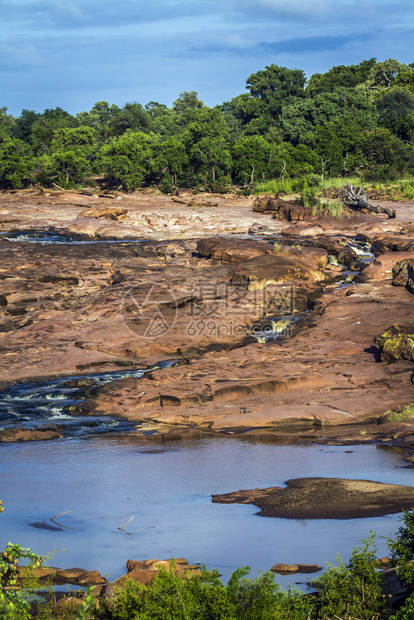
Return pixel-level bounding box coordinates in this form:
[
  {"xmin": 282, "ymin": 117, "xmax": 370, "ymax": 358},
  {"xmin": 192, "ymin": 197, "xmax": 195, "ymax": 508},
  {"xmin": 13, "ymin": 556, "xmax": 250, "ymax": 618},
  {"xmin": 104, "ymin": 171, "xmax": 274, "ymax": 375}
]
[{"xmin": 0, "ymin": 0, "xmax": 414, "ymax": 116}]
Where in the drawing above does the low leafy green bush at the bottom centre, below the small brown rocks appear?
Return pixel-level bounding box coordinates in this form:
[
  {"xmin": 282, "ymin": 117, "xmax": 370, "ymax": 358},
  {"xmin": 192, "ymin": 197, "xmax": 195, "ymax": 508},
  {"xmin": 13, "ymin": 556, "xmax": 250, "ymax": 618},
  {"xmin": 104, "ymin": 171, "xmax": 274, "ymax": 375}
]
[{"xmin": 97, "ymin": 567, "xmax": 313, "ymax": 620}]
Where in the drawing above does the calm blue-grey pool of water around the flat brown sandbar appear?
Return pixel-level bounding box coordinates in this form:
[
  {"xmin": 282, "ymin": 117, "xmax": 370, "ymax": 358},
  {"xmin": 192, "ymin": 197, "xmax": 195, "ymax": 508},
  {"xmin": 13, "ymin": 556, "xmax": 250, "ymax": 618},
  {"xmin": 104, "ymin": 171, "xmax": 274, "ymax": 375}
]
[{"xmin": 0, "ymin": 437, "xmax": 413, "ymax": 585}]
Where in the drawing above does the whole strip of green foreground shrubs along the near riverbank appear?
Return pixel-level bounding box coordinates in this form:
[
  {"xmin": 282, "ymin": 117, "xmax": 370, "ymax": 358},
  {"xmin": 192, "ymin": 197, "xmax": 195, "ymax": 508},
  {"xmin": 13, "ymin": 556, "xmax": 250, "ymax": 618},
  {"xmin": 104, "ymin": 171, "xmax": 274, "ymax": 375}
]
[{"xmin": 0, "ymin": 502, "xmax": 414, "ymax": 620}]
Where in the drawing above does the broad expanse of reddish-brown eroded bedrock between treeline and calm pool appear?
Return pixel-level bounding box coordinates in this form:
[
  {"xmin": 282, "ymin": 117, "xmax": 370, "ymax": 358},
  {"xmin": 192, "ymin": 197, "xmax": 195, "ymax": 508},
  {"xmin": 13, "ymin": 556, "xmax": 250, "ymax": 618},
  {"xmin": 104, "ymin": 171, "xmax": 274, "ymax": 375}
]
[{"xmin": 0, "ymin": 193, "xmax": 414, "ymax": 440}]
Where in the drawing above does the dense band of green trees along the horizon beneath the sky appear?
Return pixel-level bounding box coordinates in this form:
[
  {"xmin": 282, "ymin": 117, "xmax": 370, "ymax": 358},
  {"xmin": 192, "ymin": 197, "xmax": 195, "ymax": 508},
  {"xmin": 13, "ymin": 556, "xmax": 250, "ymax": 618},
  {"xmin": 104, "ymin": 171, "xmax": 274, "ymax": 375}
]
[{"xmin": 0, "ymin": 58, "xmax": 414, "ymax": 192}]
